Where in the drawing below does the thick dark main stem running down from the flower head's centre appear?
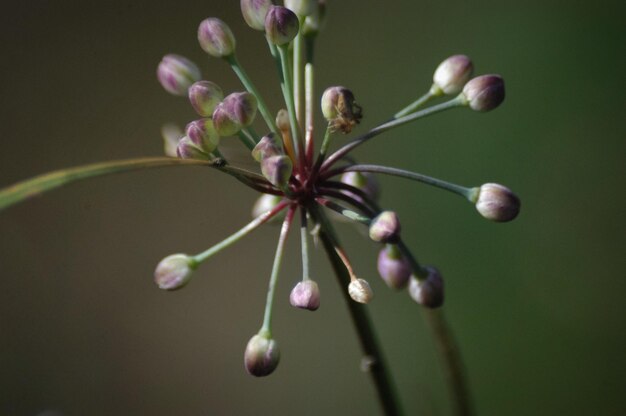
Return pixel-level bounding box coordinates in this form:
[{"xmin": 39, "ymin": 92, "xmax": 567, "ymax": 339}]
[{"xmin": 310, "ymin": 206, "xmax": 402, "ymax": 416}]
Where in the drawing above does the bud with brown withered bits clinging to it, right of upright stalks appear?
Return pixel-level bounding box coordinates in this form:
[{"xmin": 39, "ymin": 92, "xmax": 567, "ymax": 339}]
[{"xmin": 322, "ymin": 87, "xmax": 363, "ymax": 134}]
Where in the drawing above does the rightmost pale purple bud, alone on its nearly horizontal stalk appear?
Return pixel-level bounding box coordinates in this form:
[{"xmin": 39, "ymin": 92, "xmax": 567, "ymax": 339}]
[{"xmin": 476, "ymin": 183, "xmax": 521, "ymax": 222}]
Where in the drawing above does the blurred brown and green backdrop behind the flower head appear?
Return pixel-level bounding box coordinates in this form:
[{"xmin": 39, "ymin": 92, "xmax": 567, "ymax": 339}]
[{"xmin": 0, "ymin": 0, "xmax": 626, "ymax": 416}]
